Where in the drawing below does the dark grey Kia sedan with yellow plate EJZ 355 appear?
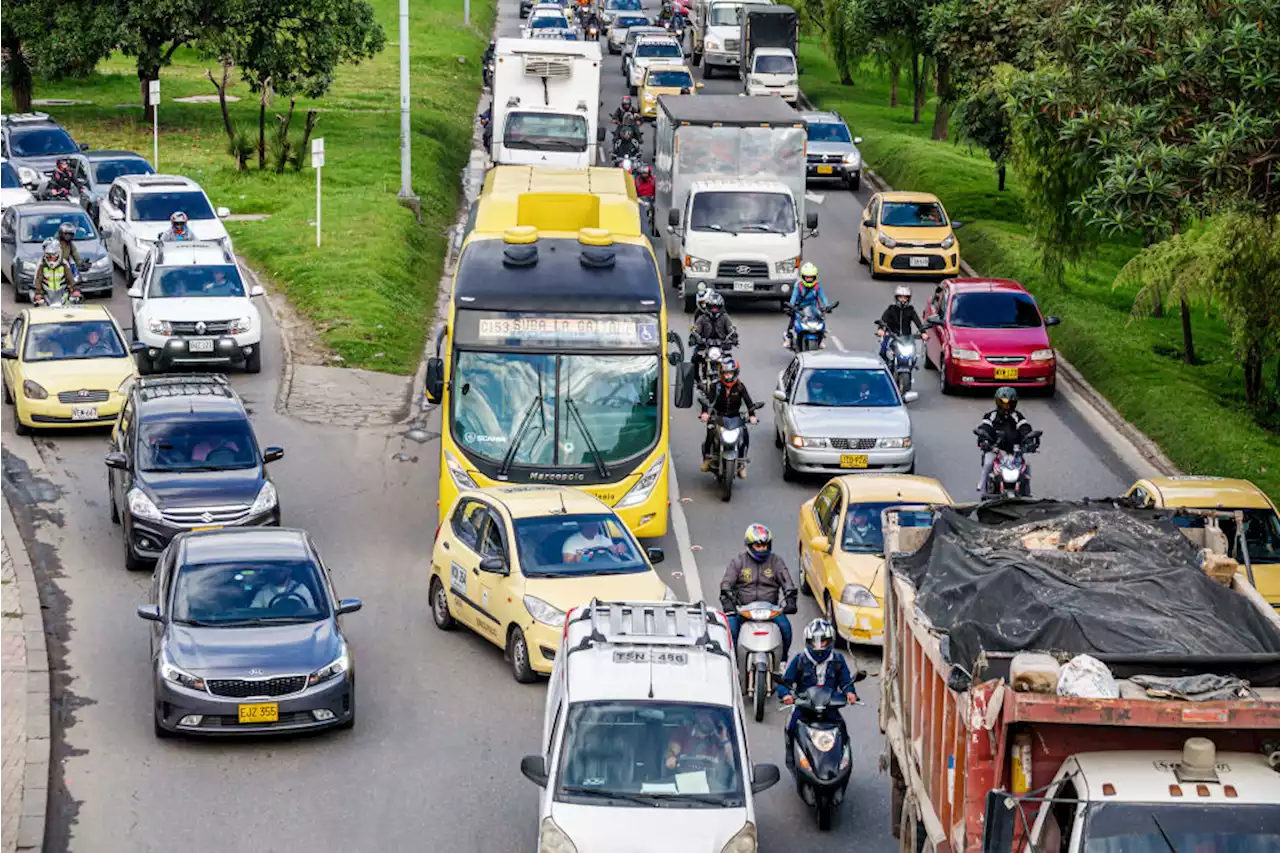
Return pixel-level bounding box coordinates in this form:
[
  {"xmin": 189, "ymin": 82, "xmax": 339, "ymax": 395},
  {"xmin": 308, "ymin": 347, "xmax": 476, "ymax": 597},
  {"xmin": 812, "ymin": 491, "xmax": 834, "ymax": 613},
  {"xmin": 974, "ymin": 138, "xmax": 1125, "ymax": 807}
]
[{"xmin": 138, "ymin": 528, "xmax": 361, "ymax": 738}]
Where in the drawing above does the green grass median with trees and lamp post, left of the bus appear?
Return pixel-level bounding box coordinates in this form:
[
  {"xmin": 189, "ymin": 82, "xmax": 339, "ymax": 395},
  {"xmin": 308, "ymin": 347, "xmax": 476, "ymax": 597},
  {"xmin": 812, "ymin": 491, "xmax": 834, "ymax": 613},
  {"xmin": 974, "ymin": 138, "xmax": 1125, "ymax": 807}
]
[{"xmin": 0, "ymin": 0, "xmax": 494, "ymax": 374}]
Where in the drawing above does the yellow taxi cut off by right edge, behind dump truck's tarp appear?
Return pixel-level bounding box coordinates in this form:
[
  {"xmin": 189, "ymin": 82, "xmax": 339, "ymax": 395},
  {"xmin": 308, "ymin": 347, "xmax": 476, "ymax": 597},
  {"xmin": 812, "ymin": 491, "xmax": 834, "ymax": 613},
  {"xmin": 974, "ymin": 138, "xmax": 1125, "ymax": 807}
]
[{"xmin": 1126, "ymin": 476, "xmax": 1280, "ymax": 608}]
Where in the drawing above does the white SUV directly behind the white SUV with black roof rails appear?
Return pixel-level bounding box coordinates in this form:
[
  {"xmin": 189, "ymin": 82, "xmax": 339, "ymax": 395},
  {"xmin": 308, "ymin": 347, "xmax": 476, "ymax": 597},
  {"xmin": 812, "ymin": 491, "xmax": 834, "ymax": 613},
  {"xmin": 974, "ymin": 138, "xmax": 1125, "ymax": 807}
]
[{"xmin": 97, "ymin": 174, "xmax": 232, "ymax": 282}]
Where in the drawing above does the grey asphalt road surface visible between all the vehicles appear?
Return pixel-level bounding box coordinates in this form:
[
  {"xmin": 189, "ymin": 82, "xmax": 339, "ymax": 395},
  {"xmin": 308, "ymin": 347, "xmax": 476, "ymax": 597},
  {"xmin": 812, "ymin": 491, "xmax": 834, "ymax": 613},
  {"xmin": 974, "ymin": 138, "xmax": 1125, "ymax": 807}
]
[{"xmin": 0, "ymin": 0, "xmax": 1132, "ymax": 853}]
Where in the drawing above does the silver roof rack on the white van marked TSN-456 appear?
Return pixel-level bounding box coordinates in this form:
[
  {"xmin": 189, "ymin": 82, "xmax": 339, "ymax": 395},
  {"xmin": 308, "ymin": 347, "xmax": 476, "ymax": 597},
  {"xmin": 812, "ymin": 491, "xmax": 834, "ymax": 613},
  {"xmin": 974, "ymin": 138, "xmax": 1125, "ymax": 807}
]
[{"xmin": 566, "ymin": 598, "xmax": 730, "ymax": 658}]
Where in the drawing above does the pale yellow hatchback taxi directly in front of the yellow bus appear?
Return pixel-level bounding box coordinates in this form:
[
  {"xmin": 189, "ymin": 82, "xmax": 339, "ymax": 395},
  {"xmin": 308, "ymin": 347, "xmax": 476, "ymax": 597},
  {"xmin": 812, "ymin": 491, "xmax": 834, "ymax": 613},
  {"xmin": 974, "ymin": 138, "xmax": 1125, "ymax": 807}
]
[{"xmin": 430, "ymin": 485, "xmax": 675, "ymax": 683}]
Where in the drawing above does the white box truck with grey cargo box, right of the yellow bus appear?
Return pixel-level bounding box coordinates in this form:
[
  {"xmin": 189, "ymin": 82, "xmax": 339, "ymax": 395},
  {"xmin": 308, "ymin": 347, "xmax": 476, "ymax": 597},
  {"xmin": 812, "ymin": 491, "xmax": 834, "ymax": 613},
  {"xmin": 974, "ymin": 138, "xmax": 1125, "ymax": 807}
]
[{"xmin": 654, "ymin": 95, "xmax": 818, "ymax": 313}]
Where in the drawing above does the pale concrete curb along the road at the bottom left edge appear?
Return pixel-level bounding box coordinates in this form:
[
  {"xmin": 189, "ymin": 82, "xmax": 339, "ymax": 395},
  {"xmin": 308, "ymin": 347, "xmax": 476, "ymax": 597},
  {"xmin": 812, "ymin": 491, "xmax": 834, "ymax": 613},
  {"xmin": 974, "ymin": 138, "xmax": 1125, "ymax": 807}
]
[{"xmin": 0, "ymin": 484, "xmax": 52, "ymax": 853}]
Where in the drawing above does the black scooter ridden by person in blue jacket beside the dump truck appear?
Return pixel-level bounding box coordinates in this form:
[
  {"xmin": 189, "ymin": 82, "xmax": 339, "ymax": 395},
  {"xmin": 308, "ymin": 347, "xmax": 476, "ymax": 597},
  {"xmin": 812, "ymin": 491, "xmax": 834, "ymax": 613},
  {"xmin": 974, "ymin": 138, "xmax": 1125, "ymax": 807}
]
[{"xmin": 791, "ymin": 670, "xmax": 867, "ymax": 833}]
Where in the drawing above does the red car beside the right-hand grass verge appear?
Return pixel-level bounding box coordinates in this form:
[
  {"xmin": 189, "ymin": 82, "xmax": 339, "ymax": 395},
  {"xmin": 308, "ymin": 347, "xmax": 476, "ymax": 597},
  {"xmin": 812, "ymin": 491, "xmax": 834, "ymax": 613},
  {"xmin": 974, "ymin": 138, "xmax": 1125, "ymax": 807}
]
[{"xmin": 924, "ymin": 278, "xmax": 1061, "ymax": 396}]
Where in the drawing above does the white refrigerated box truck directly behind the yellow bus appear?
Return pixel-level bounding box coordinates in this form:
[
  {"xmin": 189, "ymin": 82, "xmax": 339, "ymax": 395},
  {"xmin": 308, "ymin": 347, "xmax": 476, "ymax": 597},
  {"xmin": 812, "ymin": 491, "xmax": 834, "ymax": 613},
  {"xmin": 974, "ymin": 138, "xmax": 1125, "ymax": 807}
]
[{"xmin": 489, "ymin": 38, "xmax": 604, "ymax": 169}]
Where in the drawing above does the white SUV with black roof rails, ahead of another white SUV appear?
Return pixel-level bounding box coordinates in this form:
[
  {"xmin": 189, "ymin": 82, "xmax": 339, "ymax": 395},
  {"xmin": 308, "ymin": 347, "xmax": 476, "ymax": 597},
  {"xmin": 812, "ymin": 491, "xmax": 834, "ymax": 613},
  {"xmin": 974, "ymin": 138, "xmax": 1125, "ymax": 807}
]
[{"xmin": 129, "ymin": 241, "xmax": 264, "ymax": 374}]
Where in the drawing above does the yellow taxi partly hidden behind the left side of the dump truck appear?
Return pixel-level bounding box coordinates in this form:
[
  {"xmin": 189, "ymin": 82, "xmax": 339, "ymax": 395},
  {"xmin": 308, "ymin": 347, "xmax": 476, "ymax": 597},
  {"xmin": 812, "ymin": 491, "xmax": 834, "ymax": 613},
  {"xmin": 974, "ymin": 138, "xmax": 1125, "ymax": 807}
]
[{"xmin": 800, "ymin": 474, "xmax": 952, "ymax": 646}]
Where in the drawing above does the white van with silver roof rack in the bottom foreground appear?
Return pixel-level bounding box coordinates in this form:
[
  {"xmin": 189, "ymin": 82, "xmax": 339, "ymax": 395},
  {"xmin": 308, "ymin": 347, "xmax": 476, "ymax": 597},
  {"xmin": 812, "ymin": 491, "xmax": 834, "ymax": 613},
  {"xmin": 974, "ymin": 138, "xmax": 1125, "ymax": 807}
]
[{"xmin": 520, "ymin": 601, "xmax": 780, "ymax": 853}]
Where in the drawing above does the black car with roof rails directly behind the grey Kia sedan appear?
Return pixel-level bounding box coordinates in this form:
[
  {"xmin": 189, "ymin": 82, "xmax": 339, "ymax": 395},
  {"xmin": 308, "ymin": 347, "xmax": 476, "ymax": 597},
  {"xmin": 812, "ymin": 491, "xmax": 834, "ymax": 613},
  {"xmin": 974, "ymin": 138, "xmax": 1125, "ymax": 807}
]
[{"xmin": 106, "ymin": 374, "xmax": 284, "ymax": 569}]
